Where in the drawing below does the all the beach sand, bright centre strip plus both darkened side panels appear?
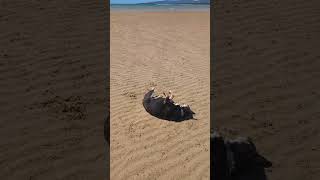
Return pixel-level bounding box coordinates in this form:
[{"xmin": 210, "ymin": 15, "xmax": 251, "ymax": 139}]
[{"xmin": 0, "ymin": 0, "xmax": 320, "ymax": 180}]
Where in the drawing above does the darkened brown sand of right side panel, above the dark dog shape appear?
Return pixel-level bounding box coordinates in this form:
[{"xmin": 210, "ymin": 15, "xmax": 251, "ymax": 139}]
[{"xmin": 212, "ymin": 0, "xmax": 320, "ymax": 180}]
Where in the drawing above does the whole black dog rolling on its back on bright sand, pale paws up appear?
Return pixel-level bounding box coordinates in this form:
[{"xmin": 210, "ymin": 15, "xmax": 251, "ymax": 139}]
[{"xmin": 142, "ymin": 88, "xmax": 195, "ymax": 121}]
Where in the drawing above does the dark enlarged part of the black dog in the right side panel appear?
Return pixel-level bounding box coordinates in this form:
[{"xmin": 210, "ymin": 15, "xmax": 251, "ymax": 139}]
[{"xmin": 210, "ymin": 133, "xmax": 272, "ymax": 180}]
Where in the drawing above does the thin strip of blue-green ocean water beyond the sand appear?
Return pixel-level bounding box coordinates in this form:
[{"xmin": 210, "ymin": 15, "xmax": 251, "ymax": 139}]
[{"xmin": 110, "ymin": 4, "xmax": 210, "ymax": 11}]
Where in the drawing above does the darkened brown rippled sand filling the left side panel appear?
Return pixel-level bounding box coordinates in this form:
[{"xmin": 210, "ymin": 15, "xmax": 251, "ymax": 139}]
[{"xmin": 0, "ymin": 0, "xmax": 108, "ymax": 180}]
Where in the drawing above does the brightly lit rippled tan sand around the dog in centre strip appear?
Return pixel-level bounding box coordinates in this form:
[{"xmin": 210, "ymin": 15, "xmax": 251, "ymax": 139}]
[{"xmin": 110, "ymin": 12, "xmax": 210, "ymax": 180}]
